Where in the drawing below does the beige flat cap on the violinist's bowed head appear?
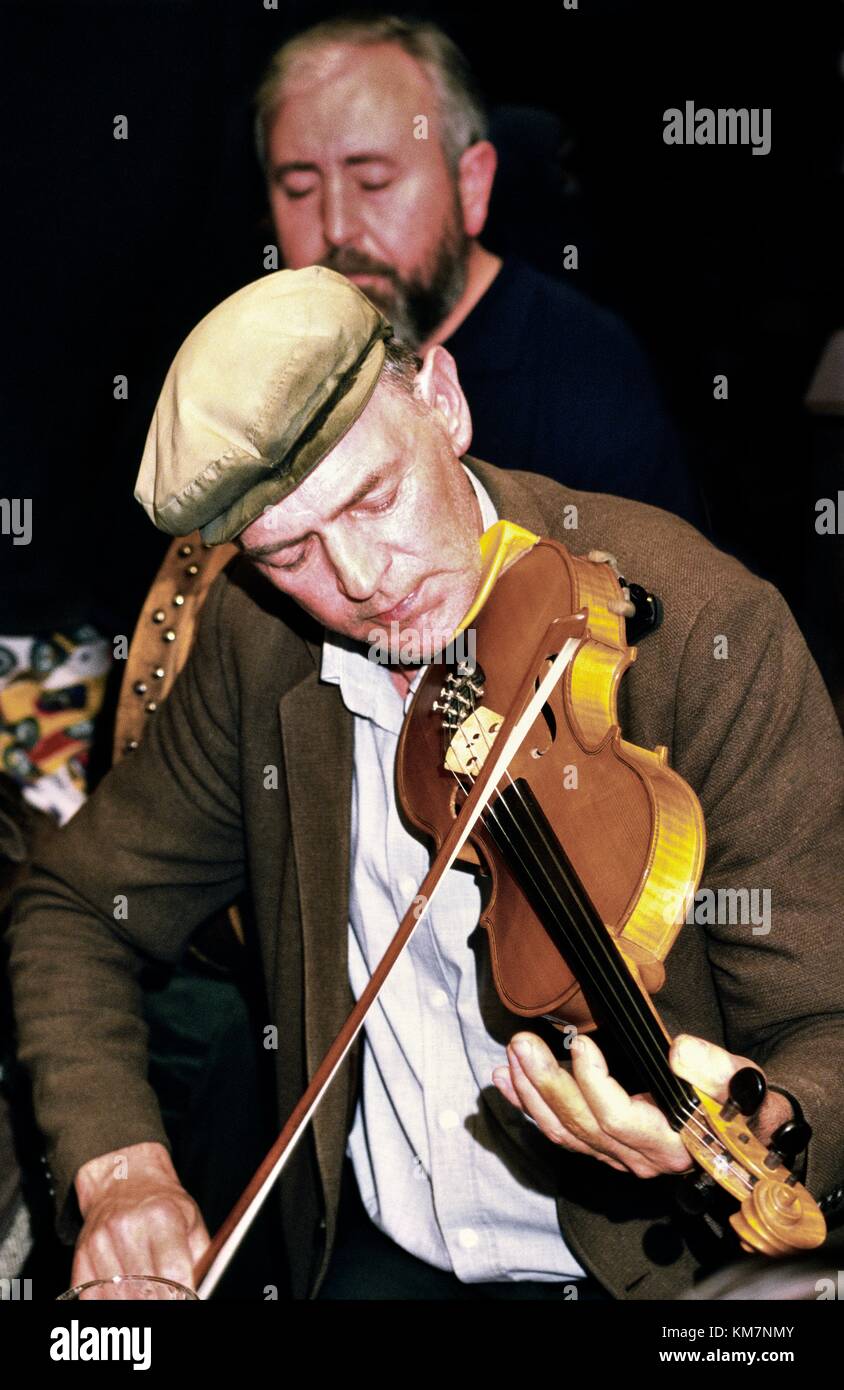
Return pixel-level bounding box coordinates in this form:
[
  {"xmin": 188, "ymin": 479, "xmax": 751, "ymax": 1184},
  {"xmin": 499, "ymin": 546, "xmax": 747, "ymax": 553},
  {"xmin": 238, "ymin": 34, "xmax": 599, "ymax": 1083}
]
[{"xmin": 135, "ymin": 265, "xmax": 392, "ymax": 545}]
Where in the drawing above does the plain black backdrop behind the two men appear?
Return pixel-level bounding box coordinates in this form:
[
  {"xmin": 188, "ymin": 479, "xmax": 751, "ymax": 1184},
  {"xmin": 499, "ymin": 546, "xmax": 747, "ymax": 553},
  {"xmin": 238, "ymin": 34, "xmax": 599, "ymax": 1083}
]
[{"xmin": 0, "ymin": 0, "xmax": 844, "ymax": 706}]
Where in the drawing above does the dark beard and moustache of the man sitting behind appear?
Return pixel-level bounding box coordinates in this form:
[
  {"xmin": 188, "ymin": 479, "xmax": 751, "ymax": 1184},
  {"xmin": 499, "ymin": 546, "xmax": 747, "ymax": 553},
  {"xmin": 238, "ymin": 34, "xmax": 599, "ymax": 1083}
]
[{"xmin": 320, "ymin": 220, "xmax": 469, "ymax": 348}]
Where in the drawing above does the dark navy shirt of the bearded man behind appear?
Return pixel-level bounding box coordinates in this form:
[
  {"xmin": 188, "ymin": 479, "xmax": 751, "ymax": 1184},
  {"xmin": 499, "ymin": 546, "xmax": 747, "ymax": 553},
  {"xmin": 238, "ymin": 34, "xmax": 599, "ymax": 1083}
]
[{"xmin": 445, "ymin": 259, "xmax": 706, "ymax": 531}]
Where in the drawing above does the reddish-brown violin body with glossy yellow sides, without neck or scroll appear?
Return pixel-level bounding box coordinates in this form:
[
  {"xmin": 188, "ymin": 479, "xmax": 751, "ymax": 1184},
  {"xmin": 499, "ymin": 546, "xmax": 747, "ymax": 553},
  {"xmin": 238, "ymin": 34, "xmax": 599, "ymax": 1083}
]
[{"xmin": 396, "ymin": 541, "xmax": 705, "ymax": 1031}]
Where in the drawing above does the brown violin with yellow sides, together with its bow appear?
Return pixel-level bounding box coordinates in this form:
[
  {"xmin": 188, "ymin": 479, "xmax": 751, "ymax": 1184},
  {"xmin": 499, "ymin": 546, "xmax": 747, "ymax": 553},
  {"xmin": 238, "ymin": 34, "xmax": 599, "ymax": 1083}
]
[{"xmin": 195, "ymin": 521, "xmax": 826, "ymax": 1297}]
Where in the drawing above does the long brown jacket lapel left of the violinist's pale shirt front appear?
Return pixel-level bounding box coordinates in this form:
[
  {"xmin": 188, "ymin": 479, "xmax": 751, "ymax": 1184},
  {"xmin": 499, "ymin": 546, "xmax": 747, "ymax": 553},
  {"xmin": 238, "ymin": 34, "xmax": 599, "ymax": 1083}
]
[{"xmin": 278, "ymin": 658, "xmax": 353, "ymax": 1204}]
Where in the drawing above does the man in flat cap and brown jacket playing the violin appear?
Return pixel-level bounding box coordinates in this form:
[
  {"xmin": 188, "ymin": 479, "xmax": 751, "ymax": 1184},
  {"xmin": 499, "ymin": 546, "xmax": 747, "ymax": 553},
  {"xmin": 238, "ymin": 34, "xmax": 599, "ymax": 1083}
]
[{"xmin": 11, "ymin": 267, "xmax": 844, "ymax": 1298}]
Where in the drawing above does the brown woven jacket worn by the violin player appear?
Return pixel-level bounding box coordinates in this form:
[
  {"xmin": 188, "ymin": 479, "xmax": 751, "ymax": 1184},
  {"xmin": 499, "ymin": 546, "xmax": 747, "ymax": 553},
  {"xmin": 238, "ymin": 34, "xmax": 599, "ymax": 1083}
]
[{"xmin": 11, "ymin": 460, "xmax": 844, "ymax": 1298}]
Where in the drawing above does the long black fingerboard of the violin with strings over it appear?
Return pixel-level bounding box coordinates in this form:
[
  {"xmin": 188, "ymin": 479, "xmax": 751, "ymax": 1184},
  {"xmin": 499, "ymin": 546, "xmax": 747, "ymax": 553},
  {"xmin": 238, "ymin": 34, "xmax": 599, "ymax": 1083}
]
[{"xmin": 487, "ymin": 778, "xmax": 698, "ymax": 1129}]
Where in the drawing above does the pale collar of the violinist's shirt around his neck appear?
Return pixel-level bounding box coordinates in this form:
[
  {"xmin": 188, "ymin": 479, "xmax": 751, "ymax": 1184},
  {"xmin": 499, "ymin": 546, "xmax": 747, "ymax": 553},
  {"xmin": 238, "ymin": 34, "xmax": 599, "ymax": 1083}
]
[{"xmin": 320, "ymin": 464, "xmax": 498, "ymax": 734}]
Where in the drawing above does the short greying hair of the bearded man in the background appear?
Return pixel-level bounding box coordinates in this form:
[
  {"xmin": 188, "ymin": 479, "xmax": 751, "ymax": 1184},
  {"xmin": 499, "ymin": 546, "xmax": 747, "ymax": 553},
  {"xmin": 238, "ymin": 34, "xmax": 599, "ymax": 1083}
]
[{"xmin": 254, "ymin": 14, "xmax": 488, "ymax": 172}]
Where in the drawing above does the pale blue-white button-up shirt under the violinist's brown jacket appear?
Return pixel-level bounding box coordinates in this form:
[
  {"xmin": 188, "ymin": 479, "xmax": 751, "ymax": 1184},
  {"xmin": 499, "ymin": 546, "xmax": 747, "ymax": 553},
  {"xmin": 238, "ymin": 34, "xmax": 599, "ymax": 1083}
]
[{"xmin": 321, "ymin": 470, "xmax": 585, "ymax": 1283}]
